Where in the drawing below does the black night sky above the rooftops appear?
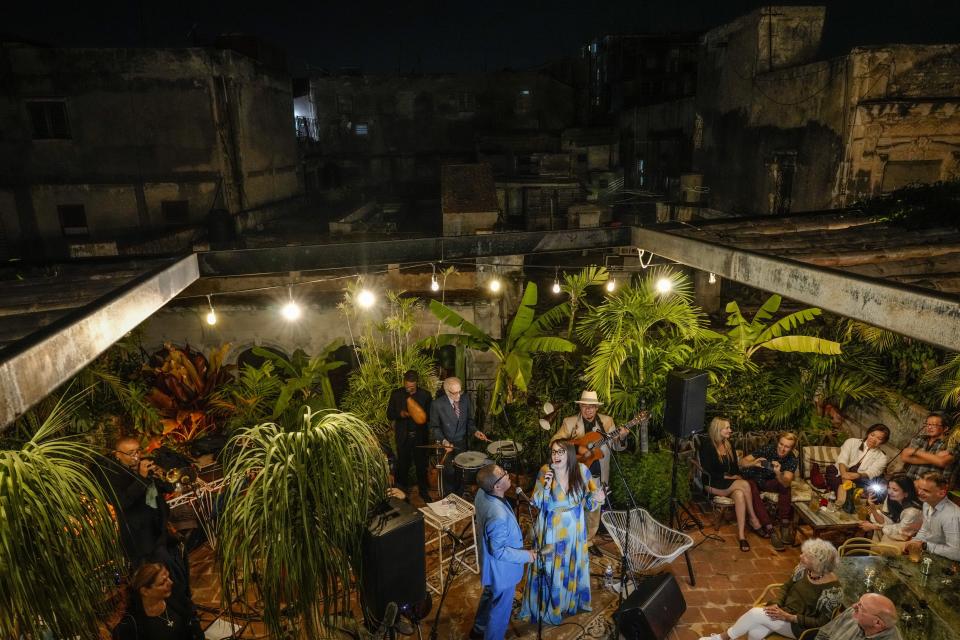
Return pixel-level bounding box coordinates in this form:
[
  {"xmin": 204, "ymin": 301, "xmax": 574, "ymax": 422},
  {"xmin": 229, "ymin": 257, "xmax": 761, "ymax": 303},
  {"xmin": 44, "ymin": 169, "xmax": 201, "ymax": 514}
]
[{"xmin": 0, "ymin": 0, "xmax": 960, "ymax": 72}]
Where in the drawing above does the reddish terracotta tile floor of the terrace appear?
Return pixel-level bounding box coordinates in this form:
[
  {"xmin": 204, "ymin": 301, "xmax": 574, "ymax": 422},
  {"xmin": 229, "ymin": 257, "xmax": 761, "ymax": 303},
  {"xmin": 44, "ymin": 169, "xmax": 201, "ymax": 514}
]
[{"xmin": 191, "ymin": 500, "xmax": 809, "ymax": 640}]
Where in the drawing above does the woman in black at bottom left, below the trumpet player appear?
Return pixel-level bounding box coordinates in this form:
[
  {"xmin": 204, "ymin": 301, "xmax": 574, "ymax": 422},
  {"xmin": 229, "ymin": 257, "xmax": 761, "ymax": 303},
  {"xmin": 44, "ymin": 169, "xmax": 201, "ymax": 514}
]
[{"xmin": 113, "ymin": 562, "xmax": 203, "ymax": 640}]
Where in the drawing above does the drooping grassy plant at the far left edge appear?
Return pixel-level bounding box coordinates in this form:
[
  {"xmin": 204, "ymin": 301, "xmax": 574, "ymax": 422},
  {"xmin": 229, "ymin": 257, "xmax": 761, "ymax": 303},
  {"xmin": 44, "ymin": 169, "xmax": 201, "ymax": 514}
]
[{"xmin": 0, "ymin": 395, "xmax": 123, "ymax": 638}]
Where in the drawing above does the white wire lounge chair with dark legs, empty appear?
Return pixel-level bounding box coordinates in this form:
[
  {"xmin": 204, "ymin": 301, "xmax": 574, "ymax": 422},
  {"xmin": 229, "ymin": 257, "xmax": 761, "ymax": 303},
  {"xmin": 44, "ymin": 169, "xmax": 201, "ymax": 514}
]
[{"xmin": 600, "ymin": 509, "xmax": 693, "ymax": 573}]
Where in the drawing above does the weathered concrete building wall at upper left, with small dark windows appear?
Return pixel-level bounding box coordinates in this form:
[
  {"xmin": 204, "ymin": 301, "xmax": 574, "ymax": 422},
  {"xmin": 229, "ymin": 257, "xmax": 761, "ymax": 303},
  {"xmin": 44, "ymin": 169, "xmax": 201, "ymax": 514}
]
[{"xmin": 0, "ymin": 44, "xmax": 302, "ymax": 252}]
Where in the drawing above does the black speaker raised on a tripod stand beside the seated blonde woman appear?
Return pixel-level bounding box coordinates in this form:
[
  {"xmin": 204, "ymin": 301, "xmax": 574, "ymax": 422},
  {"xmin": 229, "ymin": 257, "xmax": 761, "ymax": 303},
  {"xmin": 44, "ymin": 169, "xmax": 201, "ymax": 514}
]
[{"xmin": 663, "ymin": 369, "xmax": 723, "ymax": 586}]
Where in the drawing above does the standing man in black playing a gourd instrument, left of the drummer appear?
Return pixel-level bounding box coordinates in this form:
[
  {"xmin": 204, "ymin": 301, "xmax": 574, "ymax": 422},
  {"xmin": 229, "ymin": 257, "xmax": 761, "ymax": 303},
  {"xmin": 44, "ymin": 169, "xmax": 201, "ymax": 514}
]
[{"xmin": 387, "ymin": 371, "xmax": 430, "ymax": 502}]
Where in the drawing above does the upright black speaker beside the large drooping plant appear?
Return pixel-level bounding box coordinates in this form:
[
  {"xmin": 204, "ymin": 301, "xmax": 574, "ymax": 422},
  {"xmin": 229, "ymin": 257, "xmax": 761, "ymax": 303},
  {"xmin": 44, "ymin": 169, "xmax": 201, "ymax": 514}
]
[{"xmin": 362, "ymin": 498, "xmax": 427, "ymax": 620}]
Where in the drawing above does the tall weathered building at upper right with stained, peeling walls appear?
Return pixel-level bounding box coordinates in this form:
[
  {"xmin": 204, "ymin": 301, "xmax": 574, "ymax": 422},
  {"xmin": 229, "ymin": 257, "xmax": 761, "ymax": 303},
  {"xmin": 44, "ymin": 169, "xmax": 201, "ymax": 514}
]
[{"xmin": 693, "ymin": 7, "xmax": 960, "ymax": 213}]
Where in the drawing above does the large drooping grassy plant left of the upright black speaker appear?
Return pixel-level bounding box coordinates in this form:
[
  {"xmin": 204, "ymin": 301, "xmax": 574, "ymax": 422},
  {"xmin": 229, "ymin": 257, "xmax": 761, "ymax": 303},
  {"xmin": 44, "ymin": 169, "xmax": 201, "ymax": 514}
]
[{"xmin": 219, "ymin": 408, "xmax": 387, "ymax": 639}]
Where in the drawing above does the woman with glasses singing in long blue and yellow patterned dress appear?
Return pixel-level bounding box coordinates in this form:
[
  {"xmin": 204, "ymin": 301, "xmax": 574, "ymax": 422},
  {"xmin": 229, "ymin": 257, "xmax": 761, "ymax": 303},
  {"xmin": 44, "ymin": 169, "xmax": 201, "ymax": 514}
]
[{"xmin": 520, "ymin": 440, "xmax": 605, "ymax": 624}]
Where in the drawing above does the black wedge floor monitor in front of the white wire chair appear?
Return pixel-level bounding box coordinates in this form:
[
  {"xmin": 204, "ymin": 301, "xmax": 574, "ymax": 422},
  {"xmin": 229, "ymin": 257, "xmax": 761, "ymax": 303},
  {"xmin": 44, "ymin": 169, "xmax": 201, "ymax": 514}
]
[{"xmin": 613, "ymin": 573, "xmax": 687, "ymax": 640}]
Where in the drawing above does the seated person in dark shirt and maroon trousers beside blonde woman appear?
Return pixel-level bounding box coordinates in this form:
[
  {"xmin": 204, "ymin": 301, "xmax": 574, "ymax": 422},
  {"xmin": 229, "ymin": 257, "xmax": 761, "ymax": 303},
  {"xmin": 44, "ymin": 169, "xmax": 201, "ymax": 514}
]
[{"xmin": 743, "ymin": 431, "xmax": 800, "ymax": 551}]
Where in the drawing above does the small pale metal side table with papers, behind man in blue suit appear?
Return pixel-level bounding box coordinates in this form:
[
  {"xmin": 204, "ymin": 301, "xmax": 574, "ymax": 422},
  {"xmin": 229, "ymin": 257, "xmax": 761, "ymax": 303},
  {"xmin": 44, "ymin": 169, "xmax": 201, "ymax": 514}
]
[{"xmin": 420, "ymin": 494, "xmax": 480, "ymax": 594}]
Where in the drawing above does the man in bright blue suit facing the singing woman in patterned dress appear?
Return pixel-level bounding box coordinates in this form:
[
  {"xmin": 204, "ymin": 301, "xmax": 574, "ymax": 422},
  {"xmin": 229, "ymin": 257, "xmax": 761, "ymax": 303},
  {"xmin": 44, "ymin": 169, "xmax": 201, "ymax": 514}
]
[{"xmin": 470, "ymin": 464, "xmax": 536, "ymax": 640}]
